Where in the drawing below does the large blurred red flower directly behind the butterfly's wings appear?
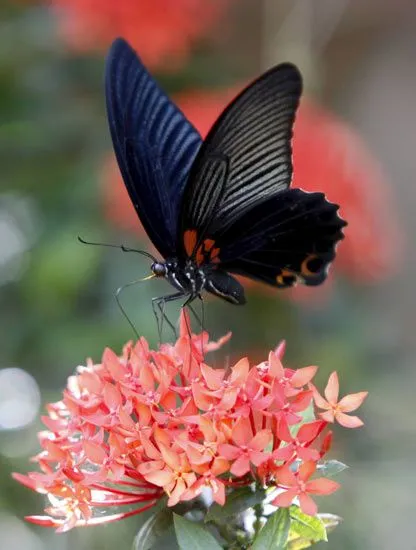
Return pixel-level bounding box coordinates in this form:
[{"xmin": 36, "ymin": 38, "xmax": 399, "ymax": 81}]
[{"xmin": 105, "ymin": 88, "xmax": 401, "ymax": 288}]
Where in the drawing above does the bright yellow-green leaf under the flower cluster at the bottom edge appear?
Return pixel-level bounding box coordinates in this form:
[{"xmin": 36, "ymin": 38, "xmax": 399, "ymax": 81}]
[{"xmin": 289, "ymin": 506, "xmax": 328, "ymax": 550}]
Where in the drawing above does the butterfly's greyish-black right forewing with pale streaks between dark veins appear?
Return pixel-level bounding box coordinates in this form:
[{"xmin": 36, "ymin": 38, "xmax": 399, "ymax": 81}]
[{"xmin": 178, "ymin": 63, "xmax": 302, "ymax": 256}]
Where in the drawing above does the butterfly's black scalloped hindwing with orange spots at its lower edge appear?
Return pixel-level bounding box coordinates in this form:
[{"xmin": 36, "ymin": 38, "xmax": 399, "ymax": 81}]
[{"xmin": 216, "ymin": 189, "xmax": 346, "ymax": 288}]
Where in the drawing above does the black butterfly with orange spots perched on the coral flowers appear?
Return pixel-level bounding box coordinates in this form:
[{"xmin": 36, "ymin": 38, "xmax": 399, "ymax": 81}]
[{"xmin": 106, "ymin": 39, "xmax": 346, "ymax": 324}]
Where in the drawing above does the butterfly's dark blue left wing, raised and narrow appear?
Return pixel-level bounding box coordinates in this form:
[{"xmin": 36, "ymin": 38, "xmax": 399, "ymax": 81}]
[{"xmin": 105, "ymin": 38, "xmax": 201, "ymax": 257}]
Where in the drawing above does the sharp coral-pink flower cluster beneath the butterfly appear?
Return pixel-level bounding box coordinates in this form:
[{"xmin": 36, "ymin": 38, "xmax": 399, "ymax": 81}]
[{"xmin": 15, "ymin": 313, "xmax": 366, "ymax": 532}]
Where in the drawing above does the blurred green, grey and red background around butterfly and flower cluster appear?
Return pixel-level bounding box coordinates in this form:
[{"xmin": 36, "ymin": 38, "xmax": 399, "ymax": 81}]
[{"xmin": 0, "ymin": 0, "xmax": 416, "ymax": 550}]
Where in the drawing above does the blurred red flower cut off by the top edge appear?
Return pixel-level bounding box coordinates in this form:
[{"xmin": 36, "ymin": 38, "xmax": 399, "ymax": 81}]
[{"xmin": 51, "ymin": 0, "xmax": 229, "ymax": 68}]
